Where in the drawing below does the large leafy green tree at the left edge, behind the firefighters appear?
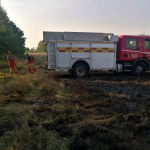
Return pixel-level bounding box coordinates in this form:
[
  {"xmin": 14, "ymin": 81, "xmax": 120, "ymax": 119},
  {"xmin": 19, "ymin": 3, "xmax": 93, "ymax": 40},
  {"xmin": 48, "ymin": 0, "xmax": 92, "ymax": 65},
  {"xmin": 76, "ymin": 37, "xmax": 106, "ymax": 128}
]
[{"xmin": 0, "ymin": 4, "xmax": 26, "ymax": 59}]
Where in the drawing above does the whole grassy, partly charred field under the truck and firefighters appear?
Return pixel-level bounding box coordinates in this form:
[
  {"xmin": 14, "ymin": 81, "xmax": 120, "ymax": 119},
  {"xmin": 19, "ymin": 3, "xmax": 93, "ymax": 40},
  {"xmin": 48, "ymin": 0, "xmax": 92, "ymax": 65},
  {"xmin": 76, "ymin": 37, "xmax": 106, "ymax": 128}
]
[{"xmin": 0, "ymin": 54, "xmax": 150, "ymax": 150}]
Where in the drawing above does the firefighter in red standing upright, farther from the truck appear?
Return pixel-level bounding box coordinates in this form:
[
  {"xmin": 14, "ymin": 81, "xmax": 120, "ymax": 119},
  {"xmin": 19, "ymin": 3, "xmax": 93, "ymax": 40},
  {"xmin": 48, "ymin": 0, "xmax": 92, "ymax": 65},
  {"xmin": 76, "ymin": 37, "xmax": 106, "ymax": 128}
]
[{"xmin": 7, "ymin": 51, "xmax": 17, "ymax": 75}]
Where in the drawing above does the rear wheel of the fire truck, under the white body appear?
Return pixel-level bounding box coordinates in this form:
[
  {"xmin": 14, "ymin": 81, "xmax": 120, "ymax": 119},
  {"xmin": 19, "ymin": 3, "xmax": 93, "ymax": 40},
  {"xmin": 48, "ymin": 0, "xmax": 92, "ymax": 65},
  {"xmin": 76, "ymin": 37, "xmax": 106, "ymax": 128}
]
[{"xmin": 73, "ymin": 63, "xmax": 89, "ymax": 78}]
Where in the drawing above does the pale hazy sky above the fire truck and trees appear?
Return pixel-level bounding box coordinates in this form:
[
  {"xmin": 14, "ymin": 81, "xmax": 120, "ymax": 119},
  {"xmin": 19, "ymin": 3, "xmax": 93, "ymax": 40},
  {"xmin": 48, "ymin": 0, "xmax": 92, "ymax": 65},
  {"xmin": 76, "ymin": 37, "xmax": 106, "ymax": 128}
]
[{"xmin": 1, "ymin": 0, "xmax": 150, "ymax": 48}]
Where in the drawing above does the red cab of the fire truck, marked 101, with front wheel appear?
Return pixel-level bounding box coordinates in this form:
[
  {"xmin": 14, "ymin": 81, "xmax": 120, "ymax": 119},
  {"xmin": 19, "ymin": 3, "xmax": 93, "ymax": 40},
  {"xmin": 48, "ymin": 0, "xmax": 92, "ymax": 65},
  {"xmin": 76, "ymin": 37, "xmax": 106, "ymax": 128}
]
[{"xmin": 117, "ymin": 35, "xmax": 150, "ymax": 74}]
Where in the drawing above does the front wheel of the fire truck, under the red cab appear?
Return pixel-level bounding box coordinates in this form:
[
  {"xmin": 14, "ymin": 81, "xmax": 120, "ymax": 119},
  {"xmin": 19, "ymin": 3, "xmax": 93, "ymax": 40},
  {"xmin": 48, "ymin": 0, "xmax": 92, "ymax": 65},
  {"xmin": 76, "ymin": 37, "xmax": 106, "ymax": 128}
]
[{"xmin": 134, "ymin": 62, "xmax": 147, "ymax": 75}]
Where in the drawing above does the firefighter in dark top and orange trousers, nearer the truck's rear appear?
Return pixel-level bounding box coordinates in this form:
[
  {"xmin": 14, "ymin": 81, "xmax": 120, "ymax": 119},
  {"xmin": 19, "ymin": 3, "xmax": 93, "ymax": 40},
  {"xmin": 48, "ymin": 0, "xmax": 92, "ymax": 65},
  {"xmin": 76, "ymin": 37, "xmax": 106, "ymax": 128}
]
[{"xmin": 26, "ymin": 54, "xmax": 37, "ymax": 73}]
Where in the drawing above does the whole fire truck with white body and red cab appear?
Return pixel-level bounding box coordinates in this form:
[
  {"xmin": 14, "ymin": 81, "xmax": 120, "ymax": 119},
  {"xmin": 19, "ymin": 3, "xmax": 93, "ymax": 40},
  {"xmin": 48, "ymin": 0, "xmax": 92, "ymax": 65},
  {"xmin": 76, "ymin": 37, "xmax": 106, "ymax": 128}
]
[{"xmin": 43, "ymin": 32, "xmax": 150, "ymax": 77}]
